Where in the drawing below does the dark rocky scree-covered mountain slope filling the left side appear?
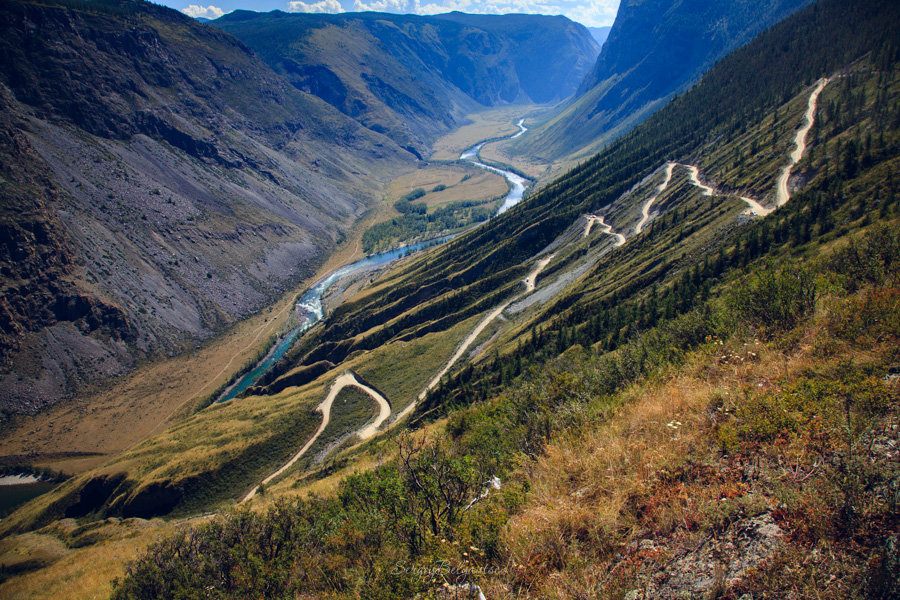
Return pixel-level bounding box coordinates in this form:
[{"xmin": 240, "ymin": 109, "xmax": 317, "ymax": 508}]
[{"xmin": 0, "ymin": 1, "xmax": 414, "ymax": 411}]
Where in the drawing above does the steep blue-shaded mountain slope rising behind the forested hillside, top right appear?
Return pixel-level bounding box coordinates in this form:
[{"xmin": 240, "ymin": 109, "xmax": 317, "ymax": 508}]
[{"xmin": 516, "ymin": 0, "xmax": 809, "ymax": 161}]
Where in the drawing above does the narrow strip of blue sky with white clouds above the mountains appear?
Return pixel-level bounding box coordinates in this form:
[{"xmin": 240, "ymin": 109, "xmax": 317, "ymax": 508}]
[{"xmin": 157, "ymin": 0, "xmax": 619, "ymax": 27}]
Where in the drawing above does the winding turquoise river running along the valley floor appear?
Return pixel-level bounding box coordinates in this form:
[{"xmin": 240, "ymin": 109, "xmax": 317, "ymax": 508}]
[{"xmin": 216, "ymin": 119, "xmax": 528, "ymax": 403}]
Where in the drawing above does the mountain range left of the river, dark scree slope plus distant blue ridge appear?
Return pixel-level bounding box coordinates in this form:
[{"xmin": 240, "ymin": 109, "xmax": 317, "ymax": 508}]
[{"xmin": 0, "ymin": 1, "xmax": 597, "ymax": 412}]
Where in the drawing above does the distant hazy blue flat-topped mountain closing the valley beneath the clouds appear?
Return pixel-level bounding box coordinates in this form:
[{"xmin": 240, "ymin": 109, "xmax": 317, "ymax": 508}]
[{"xmin": 212, "ymin": 11, "xmax": 599, "ymax": 154}]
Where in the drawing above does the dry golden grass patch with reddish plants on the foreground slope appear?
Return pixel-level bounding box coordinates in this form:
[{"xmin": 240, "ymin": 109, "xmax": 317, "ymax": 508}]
[{"xmin": 492, "ymin": 301, "xmax": 893, "ymax": 598}]
